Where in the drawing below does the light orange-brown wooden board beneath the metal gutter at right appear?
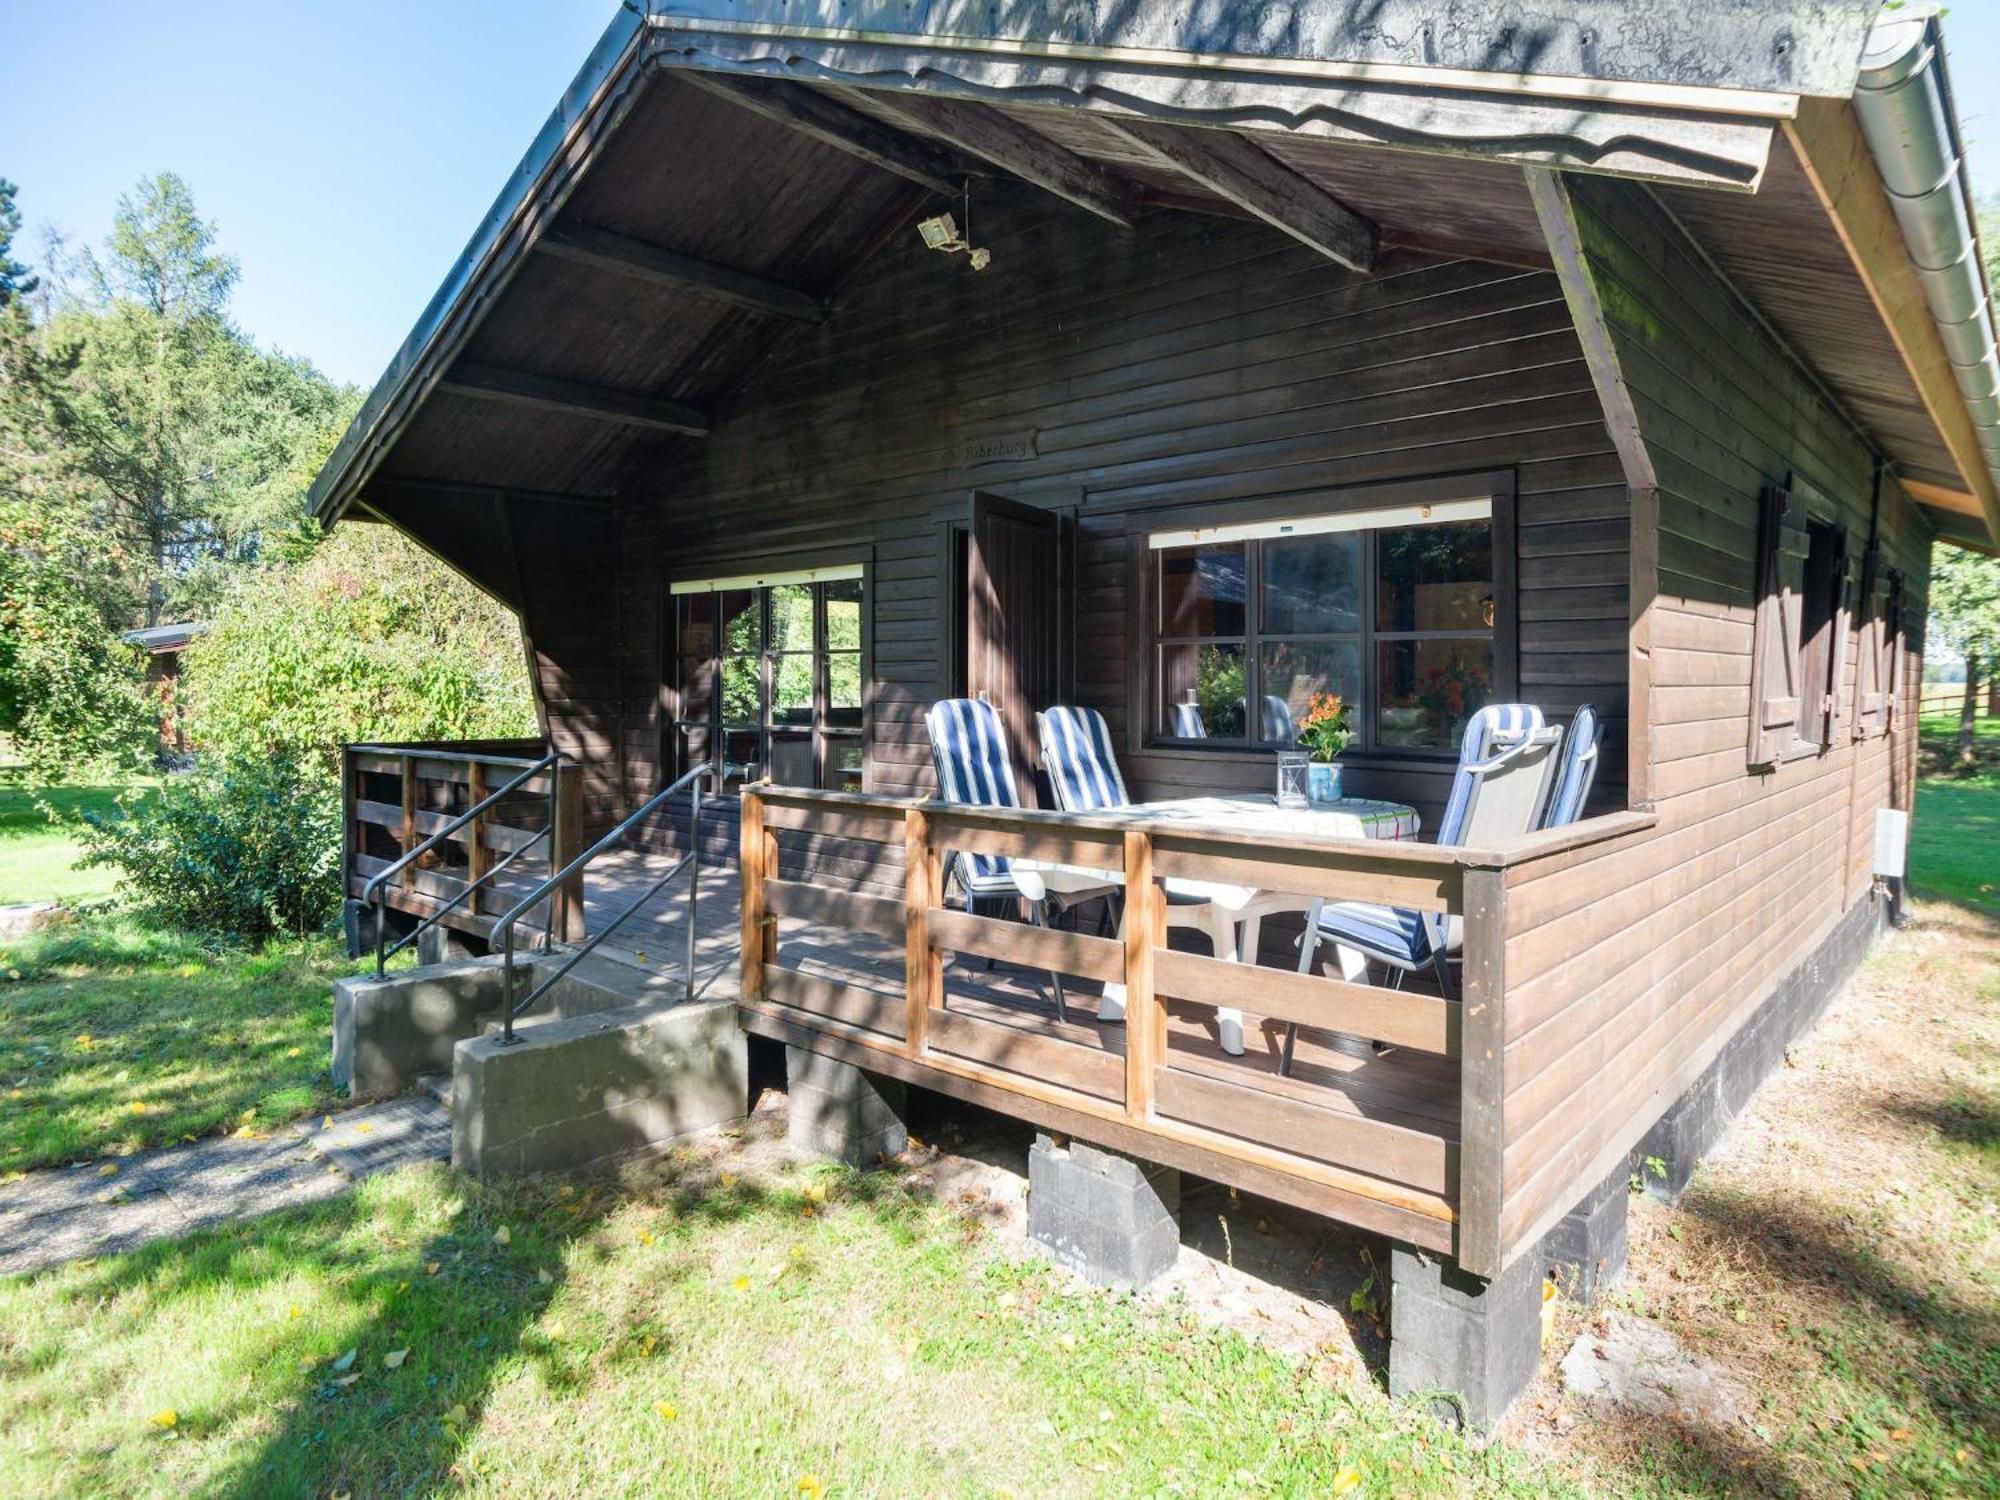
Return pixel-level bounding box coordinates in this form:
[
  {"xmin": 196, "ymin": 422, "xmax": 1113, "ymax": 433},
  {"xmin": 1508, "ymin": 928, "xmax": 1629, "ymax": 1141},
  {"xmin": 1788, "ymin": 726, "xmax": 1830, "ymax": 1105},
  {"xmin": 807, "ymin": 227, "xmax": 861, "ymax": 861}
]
[{"xmin": 1784, "ymin": 98, "xmax": 2000, "ymax": 540}]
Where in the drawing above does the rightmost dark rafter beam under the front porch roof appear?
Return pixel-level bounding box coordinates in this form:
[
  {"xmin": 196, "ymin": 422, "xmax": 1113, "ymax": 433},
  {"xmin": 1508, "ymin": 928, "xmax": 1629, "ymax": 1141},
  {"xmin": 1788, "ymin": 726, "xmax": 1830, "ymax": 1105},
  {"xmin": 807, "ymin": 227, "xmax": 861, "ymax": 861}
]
[{"xmin": 1098, "ymin": 120, "xmax": 1382, "ymax": 272}]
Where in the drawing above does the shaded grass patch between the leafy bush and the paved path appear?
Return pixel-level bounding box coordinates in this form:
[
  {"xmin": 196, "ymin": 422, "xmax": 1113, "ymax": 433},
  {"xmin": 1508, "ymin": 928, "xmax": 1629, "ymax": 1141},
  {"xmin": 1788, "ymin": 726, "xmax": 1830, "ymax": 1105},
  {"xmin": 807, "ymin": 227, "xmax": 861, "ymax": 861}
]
[{"xmin": 0, "ymin": 914, "xmax": 348, "ymax": 1178}]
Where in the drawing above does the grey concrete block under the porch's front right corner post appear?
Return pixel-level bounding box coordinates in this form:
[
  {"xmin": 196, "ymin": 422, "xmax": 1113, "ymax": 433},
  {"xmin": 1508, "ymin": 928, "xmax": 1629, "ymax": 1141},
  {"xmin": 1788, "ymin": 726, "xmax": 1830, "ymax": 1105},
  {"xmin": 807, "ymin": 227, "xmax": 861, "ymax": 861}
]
[{"xmin": 1388, "ymin": 1246, "xmax": 1542, "ymax": 1430}]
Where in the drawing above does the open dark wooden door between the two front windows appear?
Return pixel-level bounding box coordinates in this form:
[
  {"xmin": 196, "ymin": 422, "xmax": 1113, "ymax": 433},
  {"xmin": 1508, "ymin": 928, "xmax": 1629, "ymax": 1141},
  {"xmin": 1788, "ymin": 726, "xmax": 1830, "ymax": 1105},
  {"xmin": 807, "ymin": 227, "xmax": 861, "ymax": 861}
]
[{"xmin": 964, "ymin": 490, "xmax": 1068, "ymax": 776}]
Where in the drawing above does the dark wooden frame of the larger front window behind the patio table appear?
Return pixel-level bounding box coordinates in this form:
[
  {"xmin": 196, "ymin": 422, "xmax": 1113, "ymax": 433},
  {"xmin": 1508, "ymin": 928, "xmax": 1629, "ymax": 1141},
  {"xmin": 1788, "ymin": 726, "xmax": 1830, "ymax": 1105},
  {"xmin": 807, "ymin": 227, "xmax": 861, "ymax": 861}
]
[{"xmin": 1126, "ymin": 470, "xmax": 1520, "ymax": 766}]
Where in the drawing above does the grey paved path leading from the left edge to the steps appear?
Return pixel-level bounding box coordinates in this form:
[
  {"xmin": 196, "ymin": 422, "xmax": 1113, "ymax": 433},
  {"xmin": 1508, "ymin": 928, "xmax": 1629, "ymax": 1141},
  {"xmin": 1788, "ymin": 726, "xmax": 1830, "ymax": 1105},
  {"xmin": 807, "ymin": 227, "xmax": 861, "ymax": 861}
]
[{"xmin": 0, "ymin": 1094, "xmax": 452, "ymax": 1276}]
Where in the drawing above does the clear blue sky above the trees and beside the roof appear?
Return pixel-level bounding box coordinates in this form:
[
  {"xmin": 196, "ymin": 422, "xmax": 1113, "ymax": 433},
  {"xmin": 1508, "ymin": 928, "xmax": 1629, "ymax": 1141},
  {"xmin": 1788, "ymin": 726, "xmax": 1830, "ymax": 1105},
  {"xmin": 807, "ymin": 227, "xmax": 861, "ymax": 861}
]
[{"xmin": 11, "ymin": 0, "xmax": 2000, "ymax": 394}]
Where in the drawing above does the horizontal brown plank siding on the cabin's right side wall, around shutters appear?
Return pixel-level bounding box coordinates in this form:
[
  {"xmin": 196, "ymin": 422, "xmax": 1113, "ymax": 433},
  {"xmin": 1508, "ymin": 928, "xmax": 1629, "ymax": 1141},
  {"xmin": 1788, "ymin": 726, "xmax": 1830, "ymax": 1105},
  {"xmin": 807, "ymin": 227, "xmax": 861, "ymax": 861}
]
[{"xmin": 1502, "ymin": 178, "xmax": 1930, "ymax": 1246}]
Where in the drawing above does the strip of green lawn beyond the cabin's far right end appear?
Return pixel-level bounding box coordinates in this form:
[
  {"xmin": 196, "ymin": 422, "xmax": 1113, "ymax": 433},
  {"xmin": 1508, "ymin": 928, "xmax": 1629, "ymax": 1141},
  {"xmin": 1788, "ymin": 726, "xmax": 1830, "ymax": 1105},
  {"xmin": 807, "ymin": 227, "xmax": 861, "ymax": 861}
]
[{"xmin": 1910, "ymin": 714, "xmax": 2000, "ymax": 916}]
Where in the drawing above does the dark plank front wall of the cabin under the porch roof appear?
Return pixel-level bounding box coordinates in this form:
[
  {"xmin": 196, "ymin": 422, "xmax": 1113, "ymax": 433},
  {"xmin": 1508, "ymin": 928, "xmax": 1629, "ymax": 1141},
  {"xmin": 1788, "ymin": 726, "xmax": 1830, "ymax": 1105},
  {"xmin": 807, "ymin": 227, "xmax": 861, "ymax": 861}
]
[{"xmin": 604, "ymin": 188, "xmax": 1628, "ymax": 852}]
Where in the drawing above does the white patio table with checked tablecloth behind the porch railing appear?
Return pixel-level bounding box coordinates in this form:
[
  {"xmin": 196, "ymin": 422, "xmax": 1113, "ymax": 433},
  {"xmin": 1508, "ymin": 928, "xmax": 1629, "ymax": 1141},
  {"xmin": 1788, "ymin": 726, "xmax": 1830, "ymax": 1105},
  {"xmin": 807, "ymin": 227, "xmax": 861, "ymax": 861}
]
[{"xmin": 1014, "ymin": 792, "xmax": 1422, "ymax": 1056}]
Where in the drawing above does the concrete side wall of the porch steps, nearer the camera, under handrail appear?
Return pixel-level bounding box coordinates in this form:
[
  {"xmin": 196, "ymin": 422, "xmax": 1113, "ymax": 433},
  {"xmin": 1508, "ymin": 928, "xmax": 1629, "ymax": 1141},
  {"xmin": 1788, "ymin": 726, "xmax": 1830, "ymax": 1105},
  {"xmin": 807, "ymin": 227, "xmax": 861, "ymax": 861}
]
[{"xmin": 452, "ymin": 1000, "xmax": 750, "ymax": 1178}]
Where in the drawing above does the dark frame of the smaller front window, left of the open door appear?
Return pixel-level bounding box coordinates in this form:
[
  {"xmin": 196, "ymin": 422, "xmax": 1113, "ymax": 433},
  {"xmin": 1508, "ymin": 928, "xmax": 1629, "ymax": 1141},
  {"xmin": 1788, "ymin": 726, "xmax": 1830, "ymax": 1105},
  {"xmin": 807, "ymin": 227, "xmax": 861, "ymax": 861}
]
[{"xmin": 660, "ymin": 556, "xmax": 874, "ymax": 794}]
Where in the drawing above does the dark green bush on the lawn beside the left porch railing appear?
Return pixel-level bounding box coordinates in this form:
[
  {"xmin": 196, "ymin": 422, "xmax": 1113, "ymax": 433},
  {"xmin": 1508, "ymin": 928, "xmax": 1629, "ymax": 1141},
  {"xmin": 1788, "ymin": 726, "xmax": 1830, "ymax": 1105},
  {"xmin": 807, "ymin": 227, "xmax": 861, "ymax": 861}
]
[{"xmin": 80, "ymin": 754, "xmax": 340, "ymax": 942}]
